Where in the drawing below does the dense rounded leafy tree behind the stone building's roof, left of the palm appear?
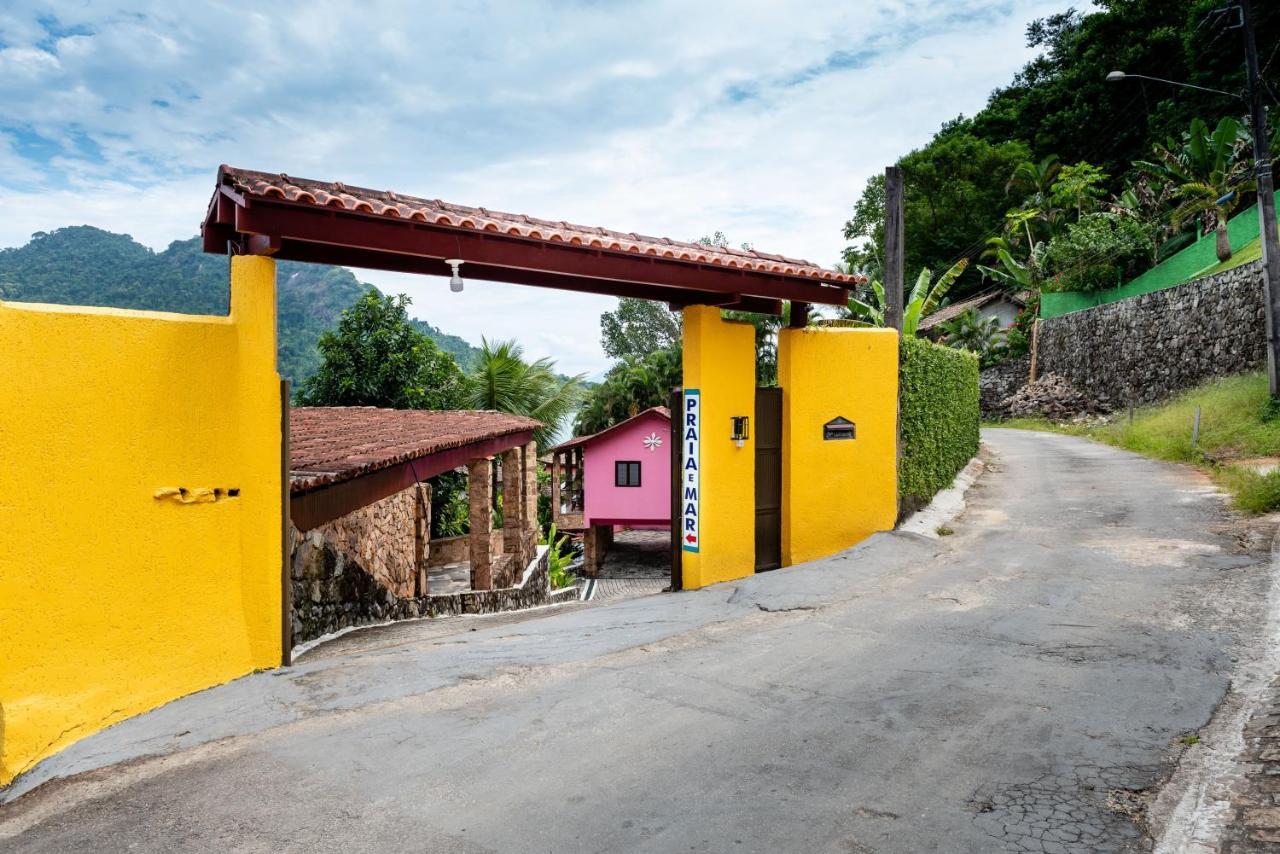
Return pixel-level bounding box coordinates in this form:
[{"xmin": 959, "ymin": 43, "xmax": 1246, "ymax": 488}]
[{"xmin": 298, "ymin": 289, "xmax": 466, "ymax": 410}]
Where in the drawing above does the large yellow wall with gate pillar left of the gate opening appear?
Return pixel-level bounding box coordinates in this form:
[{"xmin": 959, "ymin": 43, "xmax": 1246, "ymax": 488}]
[{"xmin": 0, "ymin": 257, "xmax": 282, "ymax": 785}]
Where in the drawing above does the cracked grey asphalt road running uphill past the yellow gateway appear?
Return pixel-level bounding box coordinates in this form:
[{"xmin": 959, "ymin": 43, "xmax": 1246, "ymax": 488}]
[{"xmin": 0, "ymin": 430, "xmax": 1268, "ymax": 854}]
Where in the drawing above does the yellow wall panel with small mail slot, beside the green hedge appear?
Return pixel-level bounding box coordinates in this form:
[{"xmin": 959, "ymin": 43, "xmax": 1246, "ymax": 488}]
[{"xmin": 778, "ymin": 328, "xmax": 897, "ymax": 566}]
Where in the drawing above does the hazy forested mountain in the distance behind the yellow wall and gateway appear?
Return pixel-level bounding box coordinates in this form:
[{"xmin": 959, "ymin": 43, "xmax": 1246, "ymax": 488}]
[{"xmin": 0, "ymin": 225, "xmax": 479, "ymax": 385}]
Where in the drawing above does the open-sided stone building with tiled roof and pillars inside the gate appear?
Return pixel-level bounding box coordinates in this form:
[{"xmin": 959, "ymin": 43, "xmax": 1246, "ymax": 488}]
[{"xmin": 289, "ymin": 407, "xmax": 549, "ymax": 644}]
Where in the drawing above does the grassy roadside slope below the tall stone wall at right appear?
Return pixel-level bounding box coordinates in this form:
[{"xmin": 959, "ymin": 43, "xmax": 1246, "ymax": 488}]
[{"xmin": 992, "ymin": 371, "xmax": 1280, "ymax": 513}]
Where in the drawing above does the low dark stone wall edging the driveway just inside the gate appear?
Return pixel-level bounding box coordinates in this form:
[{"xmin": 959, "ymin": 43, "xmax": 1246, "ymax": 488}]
[{"xmin": 289, "ymin": 529, "xmax": 550, "ymax": 647}]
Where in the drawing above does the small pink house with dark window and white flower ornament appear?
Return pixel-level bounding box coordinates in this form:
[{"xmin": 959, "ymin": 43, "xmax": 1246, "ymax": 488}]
[{"xmin": 550, "ymin": 406, "xmax": 671, "ymax": 574}]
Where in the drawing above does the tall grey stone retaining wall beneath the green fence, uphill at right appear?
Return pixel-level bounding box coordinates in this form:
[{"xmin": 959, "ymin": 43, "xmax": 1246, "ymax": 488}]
[{"xmin": 1037, "ymin": 261, "xmax": 1266, "ymax": 407}]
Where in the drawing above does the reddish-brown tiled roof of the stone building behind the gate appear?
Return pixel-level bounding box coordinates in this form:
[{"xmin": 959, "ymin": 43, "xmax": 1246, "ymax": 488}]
[{"xmin": 289, "ymin": 406, "xmax": 541, "ymax": 493}]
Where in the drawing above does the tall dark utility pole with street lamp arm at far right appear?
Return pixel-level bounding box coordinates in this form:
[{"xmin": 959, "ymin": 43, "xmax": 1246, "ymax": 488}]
[{"xmin": 1107, "ymin": 0, "xmax": 1280, "ymax": 399}]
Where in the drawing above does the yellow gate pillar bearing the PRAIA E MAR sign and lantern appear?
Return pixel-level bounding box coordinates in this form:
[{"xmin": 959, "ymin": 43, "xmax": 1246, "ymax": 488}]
[{"xmin": 682, "ymin": 306, "xmax": 755, "ymax": 589}]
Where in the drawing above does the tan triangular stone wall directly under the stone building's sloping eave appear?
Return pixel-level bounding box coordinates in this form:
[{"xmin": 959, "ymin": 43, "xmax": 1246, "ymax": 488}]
[{"xmin": 312, "ymin": 487, "xmax": 417, "ymax": 597}]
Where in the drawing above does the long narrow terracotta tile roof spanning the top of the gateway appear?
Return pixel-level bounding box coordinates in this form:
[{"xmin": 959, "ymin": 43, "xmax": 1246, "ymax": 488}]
[{"xmin": 219, "ymin": 165, "xmax": 865, "ymax": 286}]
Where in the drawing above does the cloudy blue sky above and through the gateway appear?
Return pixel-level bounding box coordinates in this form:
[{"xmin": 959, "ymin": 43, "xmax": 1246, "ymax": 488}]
[{"xmin": 0, "ymin": 0, "xmax": 1068, "ymax": 375}]
